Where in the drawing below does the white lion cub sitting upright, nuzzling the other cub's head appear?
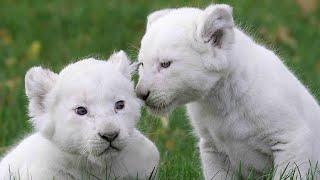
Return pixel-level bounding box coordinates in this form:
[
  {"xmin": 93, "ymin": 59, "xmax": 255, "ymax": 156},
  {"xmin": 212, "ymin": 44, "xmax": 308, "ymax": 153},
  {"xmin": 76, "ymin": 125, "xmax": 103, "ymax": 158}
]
[{"xmin": 136, "ymin": 5, "xmax": 320, "ymax": 179}]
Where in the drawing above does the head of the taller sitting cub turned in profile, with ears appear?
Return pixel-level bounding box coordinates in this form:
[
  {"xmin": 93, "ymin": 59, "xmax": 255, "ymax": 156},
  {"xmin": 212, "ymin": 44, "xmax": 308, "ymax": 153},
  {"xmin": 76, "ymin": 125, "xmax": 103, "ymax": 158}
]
[{"xmin": 136, "ymin": 5, "xmax": 234, "ymax": 113}]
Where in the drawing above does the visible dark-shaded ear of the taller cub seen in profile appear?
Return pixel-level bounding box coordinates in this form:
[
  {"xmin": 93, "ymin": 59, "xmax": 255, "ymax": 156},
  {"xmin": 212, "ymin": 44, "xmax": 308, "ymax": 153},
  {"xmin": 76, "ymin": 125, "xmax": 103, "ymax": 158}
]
[{"xmin": 196, "ymin": 4, "xmax": 234, "ymax": 48}]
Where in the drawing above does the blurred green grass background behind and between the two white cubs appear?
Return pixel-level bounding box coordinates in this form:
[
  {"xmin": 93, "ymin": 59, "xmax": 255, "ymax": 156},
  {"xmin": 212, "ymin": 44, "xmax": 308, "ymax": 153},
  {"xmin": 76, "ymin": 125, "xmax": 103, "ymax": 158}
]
[{"xmin": 0, "ymin": 0, "xmax": 320, "ymax": 179}]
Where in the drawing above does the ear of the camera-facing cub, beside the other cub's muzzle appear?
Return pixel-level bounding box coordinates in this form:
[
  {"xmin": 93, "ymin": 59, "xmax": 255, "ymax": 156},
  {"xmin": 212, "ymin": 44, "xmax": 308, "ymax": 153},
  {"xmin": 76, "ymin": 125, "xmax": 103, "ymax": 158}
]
[{"xmin": 109, "ymin": 50, "xmax": 140, "ymax": 79}]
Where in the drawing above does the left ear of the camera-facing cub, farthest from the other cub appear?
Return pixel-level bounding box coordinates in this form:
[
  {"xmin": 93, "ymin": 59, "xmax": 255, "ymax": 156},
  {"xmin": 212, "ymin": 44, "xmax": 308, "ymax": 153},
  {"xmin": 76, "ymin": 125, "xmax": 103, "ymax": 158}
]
[{"xmin": 25, "ymin": 67, "xmax": 58, "ymax": 117}]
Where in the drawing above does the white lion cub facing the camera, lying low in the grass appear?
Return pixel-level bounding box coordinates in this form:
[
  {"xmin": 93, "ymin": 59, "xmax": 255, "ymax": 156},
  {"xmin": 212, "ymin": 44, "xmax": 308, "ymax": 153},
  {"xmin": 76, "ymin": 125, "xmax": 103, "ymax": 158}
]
[{"xmin": 0, "ymin": 51, "xmax": 159, "ymax": 180}]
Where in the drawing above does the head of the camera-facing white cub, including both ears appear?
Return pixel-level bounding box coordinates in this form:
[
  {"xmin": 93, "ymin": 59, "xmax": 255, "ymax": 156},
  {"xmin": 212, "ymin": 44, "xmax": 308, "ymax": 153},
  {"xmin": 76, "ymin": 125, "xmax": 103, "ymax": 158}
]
[{"xmin": 25, "ymin": 51, "xmax": 141, "ymax": 158}]
